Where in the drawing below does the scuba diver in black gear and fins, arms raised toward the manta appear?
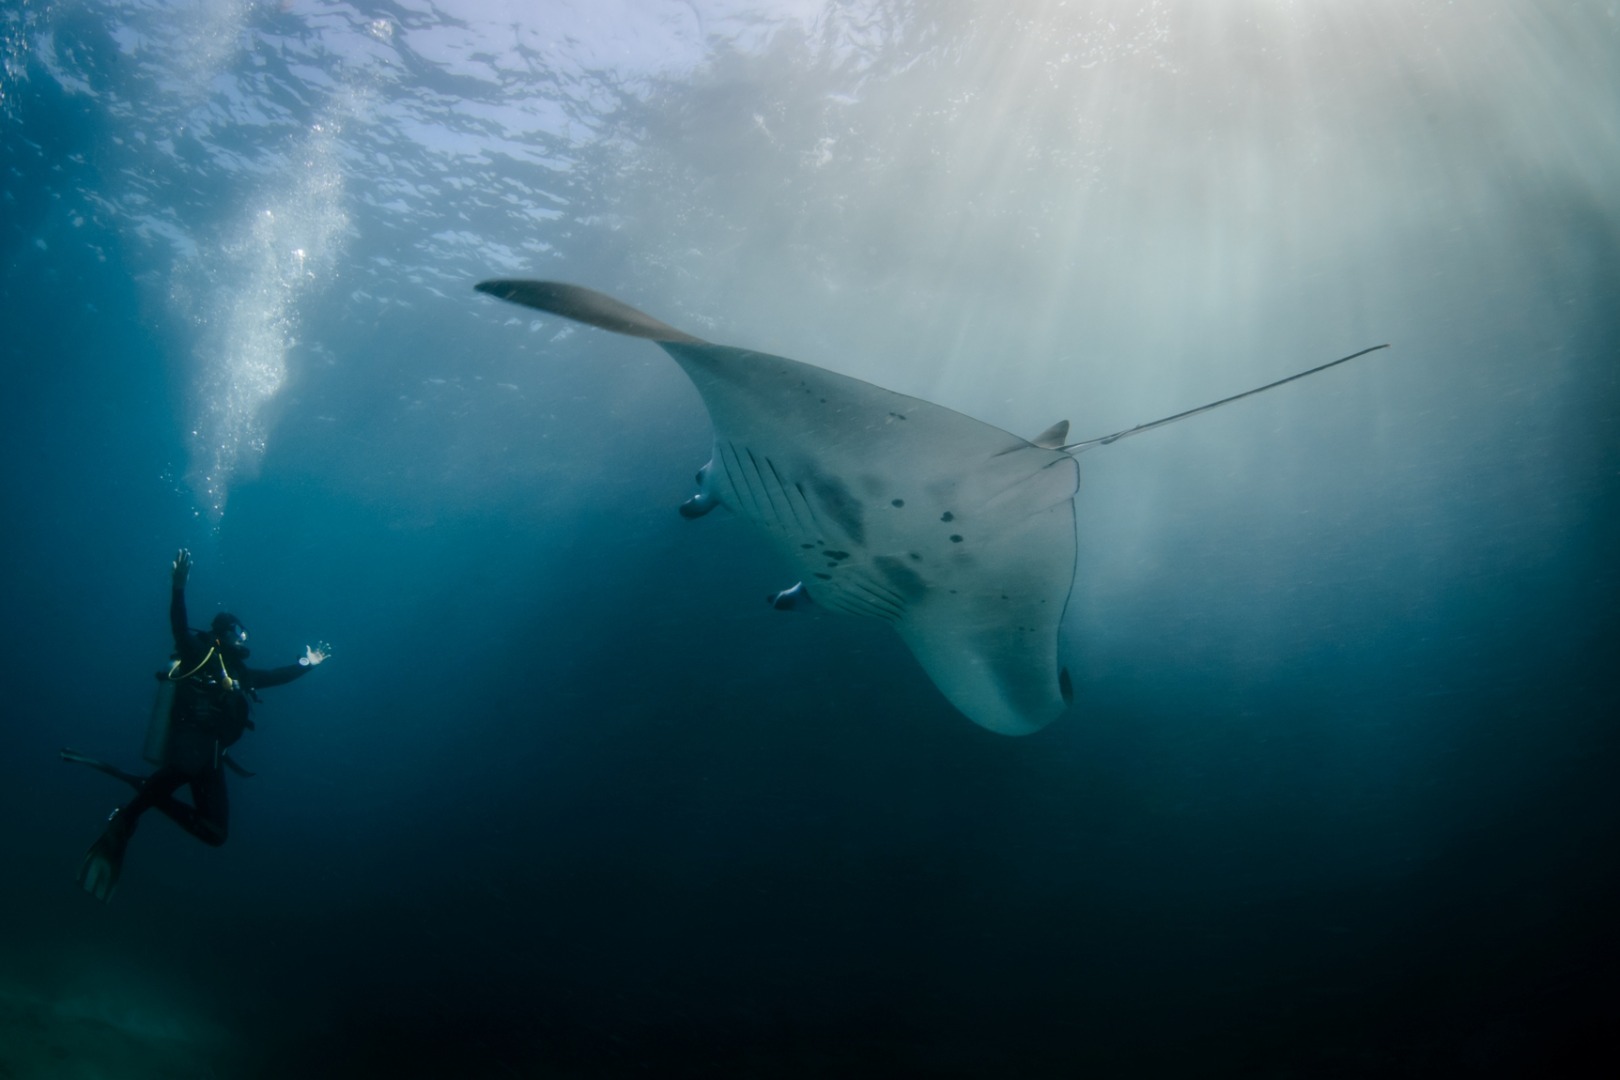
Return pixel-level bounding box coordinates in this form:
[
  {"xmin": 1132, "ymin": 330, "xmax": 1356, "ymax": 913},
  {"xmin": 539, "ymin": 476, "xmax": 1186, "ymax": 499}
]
[{"xmin": 62, "ymin": 547, "xmax": 327, "ymax": 900}]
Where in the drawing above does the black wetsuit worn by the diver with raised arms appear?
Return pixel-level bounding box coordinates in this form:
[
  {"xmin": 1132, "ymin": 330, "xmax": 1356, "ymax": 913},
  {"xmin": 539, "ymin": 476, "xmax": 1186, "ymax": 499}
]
[{"xmin": 120, "ymin": 589, "xmax": 309, "ymax": 847}]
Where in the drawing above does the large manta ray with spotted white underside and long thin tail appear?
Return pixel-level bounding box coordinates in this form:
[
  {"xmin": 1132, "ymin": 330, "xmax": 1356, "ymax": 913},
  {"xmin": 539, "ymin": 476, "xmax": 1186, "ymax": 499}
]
[{"xmin": 478, "ymin": 280, "xmax": 1383, "ymax": 735}]
